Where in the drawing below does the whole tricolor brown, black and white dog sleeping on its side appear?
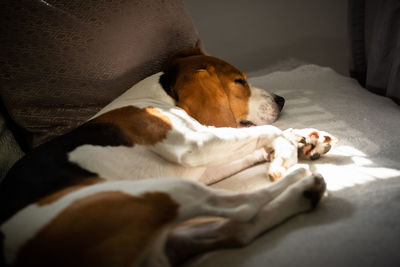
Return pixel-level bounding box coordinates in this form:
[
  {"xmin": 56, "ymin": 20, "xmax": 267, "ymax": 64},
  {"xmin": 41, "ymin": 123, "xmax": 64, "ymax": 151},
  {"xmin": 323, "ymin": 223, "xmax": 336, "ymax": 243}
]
[{"xmin": 0, "ymin": 47, "xmax": 335, "ymax": 266}]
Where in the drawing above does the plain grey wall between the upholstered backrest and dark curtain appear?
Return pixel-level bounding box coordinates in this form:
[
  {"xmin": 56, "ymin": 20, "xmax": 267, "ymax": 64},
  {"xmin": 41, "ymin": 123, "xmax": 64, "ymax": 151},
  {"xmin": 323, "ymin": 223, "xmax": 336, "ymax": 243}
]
[{"xmin": 184, "ymin": 0, "xmax": 348, "ymax": 75}]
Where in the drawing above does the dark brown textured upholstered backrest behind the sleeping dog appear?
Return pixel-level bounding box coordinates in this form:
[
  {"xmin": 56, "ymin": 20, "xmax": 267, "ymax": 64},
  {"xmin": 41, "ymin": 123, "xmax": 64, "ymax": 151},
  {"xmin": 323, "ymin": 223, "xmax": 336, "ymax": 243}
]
[{"xmin": 0, "ymin": 0, "xmax": 198, "ymax": 149}]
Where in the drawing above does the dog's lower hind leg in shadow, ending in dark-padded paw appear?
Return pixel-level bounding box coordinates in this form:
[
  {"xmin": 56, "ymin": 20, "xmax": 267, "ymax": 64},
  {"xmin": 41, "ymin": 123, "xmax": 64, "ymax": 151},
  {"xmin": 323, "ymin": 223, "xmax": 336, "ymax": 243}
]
[{"xmin": 166, "ymin": 170, "xmax": 326, "ymax": 265}]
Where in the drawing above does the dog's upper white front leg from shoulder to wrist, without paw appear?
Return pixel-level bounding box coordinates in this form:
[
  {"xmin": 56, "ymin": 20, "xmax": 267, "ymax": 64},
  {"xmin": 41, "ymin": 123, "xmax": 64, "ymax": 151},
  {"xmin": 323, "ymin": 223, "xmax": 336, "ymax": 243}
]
[{"xmin": 151, "ymin": 114, "xmax": 283, "ymax": 167}]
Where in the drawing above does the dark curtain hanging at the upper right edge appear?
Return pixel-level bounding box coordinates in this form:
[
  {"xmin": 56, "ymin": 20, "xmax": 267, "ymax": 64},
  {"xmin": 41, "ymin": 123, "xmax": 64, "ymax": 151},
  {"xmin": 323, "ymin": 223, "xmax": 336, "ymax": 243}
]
[{"xmin": 349, "ymin": 0, "xmax": 400, "ymax": 104}]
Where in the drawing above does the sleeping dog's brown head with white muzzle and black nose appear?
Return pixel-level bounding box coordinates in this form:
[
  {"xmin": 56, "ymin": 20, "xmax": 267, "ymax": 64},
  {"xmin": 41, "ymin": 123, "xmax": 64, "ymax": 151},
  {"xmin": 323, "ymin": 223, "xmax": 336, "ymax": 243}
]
[{"xmin": 160, "ymin": 47, "xmax": 285, "ymax": 127}]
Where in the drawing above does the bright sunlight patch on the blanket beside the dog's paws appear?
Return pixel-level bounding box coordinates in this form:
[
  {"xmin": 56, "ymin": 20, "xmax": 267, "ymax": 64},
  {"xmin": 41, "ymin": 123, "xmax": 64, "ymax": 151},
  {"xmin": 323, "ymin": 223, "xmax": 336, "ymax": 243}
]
[{"xmin": 311, "ymin": 146, "xmax": 400, "ymax": 191}]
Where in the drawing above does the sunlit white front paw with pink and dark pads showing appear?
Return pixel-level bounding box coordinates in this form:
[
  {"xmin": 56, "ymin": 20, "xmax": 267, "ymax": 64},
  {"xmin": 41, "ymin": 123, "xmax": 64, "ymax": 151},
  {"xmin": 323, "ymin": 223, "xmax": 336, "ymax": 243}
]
[{"xmin": 284, "ymin": 128, "xmax": 338, "ymax": 160}]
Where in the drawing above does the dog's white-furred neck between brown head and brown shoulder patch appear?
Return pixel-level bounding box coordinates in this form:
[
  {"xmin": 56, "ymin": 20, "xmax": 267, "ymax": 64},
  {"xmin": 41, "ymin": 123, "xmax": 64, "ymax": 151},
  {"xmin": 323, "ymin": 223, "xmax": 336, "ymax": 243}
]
[{"xmin": 92, "ymin": 72, "xmax": 175, "ymax": 119}]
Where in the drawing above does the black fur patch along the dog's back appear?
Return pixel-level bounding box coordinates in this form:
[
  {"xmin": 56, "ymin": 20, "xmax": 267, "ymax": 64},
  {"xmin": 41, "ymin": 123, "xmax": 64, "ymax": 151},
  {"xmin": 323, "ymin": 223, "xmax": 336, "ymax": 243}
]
[{"xmin": 0, "ymin": 122, "xmax": 133, "ymax": 224}]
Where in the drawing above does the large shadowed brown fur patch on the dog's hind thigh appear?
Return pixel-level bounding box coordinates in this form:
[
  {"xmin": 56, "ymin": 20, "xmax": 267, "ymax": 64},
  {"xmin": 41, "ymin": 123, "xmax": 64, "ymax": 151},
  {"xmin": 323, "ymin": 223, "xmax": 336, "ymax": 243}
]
[{"xmin": 16, "ymin": 192, "xmax": 178, "ymax": 267}]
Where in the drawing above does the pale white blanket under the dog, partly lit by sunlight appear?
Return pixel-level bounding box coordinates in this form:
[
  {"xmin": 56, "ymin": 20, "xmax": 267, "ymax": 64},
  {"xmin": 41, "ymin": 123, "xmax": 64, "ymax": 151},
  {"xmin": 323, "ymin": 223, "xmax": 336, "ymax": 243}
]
[{"xmin": 188, "ymin": 65, "xmax": 400, "ymax": 267}]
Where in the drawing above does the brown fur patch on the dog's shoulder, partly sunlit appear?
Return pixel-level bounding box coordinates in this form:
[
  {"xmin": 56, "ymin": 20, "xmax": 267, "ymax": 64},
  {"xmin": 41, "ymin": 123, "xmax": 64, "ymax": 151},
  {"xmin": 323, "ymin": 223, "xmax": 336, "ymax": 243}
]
[{"xmin": 91, "ymin": 106, "xmax": 172, "ymax": 145}]
